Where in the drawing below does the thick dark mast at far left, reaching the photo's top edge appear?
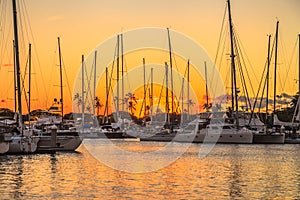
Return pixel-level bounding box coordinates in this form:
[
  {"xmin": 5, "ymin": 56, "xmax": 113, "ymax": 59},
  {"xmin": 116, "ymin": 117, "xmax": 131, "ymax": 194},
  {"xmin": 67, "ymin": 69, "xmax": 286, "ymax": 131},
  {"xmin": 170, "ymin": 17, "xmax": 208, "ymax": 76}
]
[{"xmin": 12, "ymin": 0, "xmax": 23, "ymax": 131}]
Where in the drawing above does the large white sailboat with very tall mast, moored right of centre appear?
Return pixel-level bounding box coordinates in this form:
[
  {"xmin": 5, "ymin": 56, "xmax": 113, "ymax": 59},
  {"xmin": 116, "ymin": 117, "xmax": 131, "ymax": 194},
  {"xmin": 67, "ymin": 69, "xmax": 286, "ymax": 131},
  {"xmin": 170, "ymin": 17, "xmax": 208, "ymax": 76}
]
[{"xmin": 174, "ymin": 0, "xmax": 253, "ymax": 144}]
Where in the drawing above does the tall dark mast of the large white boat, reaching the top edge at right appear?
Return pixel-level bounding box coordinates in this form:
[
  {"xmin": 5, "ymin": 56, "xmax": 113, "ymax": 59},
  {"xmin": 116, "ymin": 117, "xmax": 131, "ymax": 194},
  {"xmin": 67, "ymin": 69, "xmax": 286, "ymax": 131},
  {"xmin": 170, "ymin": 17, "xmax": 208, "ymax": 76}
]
[{"xmin": 227, "ymin": 0, "xmax": 239, "ymax": 128}]
